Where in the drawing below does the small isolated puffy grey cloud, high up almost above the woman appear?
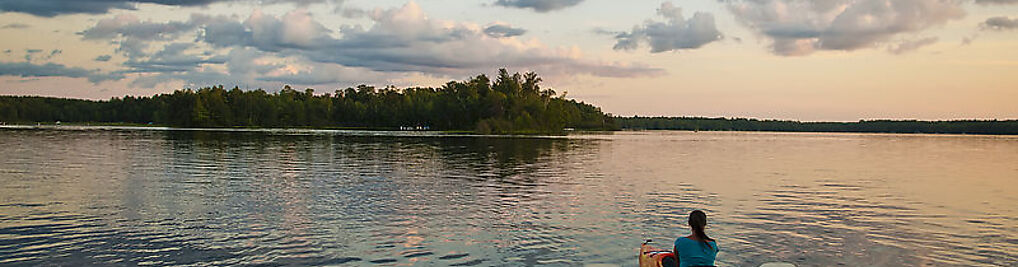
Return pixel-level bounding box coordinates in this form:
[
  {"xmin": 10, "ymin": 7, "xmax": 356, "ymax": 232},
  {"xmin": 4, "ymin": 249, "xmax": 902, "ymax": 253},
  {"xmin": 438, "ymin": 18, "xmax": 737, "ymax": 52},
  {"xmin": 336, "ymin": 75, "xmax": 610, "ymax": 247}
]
[{"xmin": 614, "ymin": 2, "xmax": 722, "ymax": 53}]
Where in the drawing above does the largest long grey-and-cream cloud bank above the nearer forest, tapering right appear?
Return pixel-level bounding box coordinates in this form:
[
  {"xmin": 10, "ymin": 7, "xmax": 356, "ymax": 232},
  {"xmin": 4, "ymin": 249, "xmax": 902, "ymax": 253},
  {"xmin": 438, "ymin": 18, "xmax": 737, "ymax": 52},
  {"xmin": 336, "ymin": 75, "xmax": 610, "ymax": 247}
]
[{"xmin": 73, "ymin": 1, "xmax": 664, "ymax": 87}]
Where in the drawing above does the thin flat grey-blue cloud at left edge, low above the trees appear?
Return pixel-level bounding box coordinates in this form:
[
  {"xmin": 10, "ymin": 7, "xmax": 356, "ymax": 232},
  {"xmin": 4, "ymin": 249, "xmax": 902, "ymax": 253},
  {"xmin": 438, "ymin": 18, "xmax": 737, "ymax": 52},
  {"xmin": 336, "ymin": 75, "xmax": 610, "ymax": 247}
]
[{"xmin": 0, "ymin": 62, "xmax": 124, "ymax": 84}]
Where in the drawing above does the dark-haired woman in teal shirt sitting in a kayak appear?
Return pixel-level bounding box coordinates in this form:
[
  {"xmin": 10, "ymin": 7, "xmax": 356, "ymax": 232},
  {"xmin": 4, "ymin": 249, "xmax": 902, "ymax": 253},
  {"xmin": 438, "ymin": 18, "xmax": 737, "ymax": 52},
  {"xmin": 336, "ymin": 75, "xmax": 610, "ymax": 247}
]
[{"xmin": 674, "ymin": 210, "xmax": 720, "ymax": 267}]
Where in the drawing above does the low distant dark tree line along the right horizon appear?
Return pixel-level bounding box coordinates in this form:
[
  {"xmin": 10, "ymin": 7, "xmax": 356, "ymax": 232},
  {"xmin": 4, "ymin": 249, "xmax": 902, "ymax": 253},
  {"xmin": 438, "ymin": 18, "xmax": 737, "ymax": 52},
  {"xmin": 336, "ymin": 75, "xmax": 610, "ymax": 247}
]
[{"xmin": 615, "ymin": 116, "xmax": 1018, "ymax": 135}]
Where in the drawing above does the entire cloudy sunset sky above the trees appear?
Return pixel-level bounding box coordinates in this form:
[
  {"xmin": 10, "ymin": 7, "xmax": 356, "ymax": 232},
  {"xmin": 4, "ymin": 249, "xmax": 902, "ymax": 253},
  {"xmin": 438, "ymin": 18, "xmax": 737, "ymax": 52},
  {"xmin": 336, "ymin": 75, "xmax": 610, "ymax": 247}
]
[{"xmin": 0, "ymin": 0, "xmax": 1018, "ymax": 121}]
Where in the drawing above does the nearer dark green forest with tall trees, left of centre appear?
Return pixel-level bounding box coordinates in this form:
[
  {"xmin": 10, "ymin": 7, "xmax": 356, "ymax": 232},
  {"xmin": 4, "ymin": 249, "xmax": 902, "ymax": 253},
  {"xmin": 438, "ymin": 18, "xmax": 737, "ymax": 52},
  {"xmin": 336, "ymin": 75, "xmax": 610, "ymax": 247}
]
[{"xmin": 0, "ymin": 69, "xmax": 618, "ymax": 134}]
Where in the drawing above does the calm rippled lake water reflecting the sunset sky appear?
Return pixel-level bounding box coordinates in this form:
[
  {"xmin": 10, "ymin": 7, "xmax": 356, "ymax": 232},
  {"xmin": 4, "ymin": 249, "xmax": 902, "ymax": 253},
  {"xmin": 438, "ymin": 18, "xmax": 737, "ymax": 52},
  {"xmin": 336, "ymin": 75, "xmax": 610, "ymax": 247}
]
[{"xmin": 0, "ymin": 127, "xmax": 1018, "ymax": 266}]
